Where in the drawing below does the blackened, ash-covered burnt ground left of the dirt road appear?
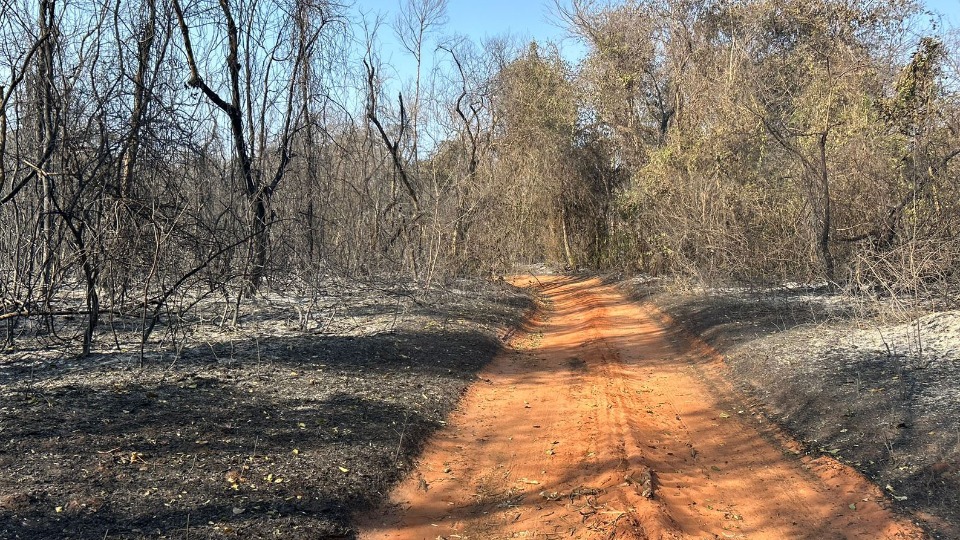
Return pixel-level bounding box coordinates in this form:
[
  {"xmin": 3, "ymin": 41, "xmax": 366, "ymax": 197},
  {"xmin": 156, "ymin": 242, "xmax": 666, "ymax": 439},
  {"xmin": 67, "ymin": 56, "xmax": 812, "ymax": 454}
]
[{"xmin": 0, "ymin": 283, "xmax": 530, "ymax": 540}]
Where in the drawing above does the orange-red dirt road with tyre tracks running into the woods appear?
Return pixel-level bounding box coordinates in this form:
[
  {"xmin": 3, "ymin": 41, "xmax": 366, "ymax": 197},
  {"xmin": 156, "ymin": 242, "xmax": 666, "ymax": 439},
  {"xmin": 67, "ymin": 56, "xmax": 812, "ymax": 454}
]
[{"xmin": 359, "ymin": 277, "xmax": 923, "ymax": 539}]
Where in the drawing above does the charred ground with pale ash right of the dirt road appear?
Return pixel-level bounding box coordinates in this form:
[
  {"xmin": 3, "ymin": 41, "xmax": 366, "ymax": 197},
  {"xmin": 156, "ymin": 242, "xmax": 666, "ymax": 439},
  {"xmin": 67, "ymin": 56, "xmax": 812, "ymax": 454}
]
[{"xmin": 618, "ymin": 279, "xmax": 960, "ymax": 538}]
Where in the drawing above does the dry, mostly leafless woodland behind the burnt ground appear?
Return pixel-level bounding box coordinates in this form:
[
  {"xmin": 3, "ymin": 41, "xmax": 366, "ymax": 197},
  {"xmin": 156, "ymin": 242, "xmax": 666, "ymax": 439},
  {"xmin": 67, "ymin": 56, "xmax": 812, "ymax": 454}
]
[{"xmin": 0, "ymin": 0, "xmax": 960, "ymax": 354}]
